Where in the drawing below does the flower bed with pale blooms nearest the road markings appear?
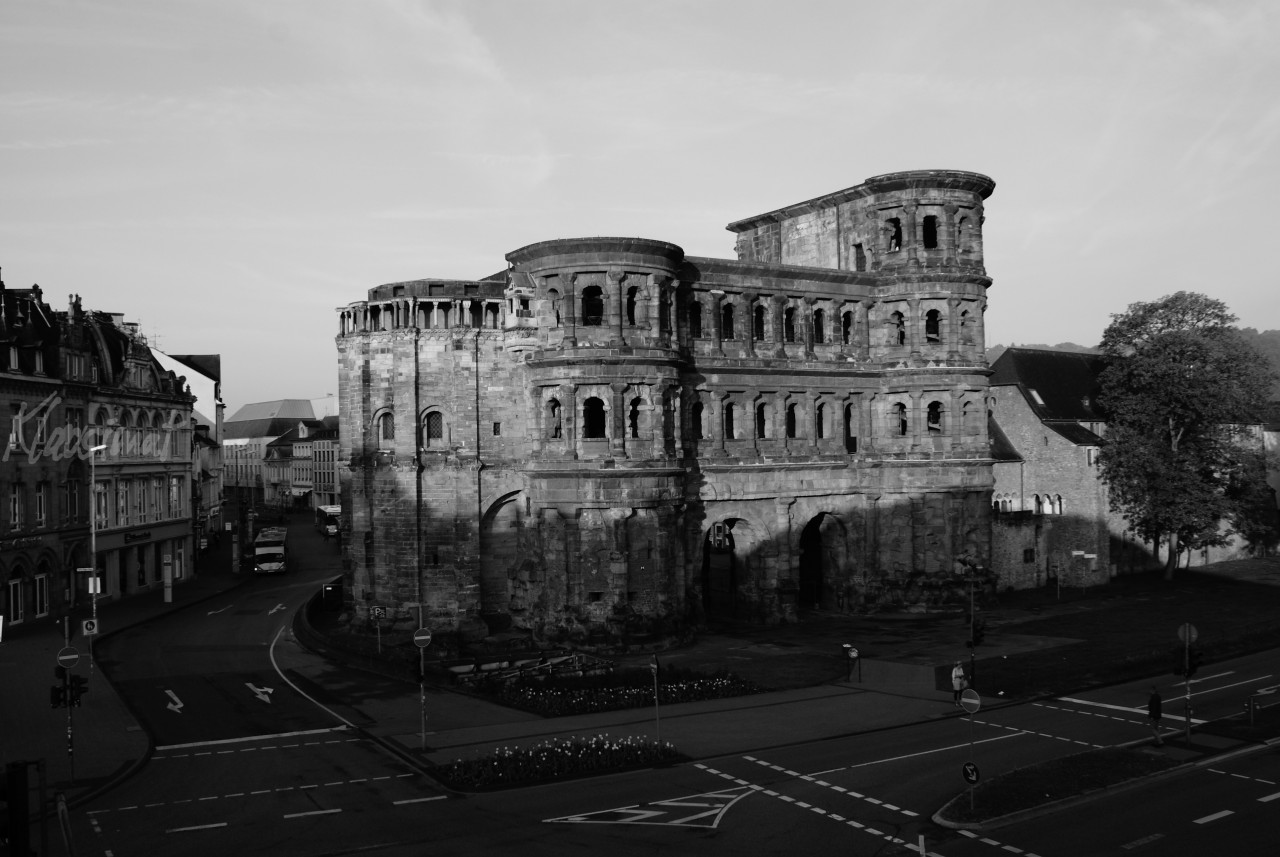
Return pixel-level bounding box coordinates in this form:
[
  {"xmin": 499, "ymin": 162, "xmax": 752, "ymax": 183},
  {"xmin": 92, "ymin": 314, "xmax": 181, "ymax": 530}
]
[{"xmin": 435, "ymin": 734, "xmax": 684, "ymax": 792}]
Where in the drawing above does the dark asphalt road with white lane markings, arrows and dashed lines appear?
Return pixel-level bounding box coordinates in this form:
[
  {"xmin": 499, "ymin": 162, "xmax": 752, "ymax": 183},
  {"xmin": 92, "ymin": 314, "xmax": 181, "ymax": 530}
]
[{"xmin": 62, "ymin": 524, "xmax": 1280, "ymax": 857}]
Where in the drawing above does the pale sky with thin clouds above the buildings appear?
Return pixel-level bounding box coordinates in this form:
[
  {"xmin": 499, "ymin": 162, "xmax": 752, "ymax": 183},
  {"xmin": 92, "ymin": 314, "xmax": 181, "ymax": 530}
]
[{"xmin": 0, "ymin": 0, "xmax": 1280, "ymax": 413}]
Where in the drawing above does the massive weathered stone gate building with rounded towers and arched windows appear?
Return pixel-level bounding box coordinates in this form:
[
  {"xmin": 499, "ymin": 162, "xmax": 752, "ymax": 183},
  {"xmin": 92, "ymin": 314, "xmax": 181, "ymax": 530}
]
[{"xmin": 337, "ymin": 170, "xmax": 995, "ymax": 642}]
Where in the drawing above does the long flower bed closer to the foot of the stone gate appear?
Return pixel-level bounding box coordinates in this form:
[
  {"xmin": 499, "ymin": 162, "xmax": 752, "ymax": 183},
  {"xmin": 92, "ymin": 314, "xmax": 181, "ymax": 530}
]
[{"xmin": 476, "ymin": 668, "xmax": 768, "ymax": 718}]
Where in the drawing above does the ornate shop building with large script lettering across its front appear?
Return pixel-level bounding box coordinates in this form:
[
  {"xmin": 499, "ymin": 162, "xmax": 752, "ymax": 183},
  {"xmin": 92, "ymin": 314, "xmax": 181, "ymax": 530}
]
[{"xmin": 0, "ymin": 283, "xmax": 193, "ymax": 624}]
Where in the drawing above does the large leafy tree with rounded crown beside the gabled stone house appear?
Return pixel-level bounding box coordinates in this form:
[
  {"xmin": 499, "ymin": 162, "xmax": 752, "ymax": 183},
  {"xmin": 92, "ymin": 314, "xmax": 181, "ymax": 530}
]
[{"xmin": 1098, "ymin": 292, "xmax": 1275, "ymax": 579}]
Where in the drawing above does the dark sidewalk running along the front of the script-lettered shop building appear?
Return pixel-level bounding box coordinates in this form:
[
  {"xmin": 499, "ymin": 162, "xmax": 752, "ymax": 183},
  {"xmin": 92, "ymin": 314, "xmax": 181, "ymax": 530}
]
[{"xmin": 0, "ymin": 539, "xmax": 250, "ymax": 805}]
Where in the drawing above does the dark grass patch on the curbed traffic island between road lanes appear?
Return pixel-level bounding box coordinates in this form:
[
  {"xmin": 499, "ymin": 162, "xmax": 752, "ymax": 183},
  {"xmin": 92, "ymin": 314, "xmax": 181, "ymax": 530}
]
[{"xmin": 938, "ymin": 747, "xmax": 1178, "ymax": 824}]
